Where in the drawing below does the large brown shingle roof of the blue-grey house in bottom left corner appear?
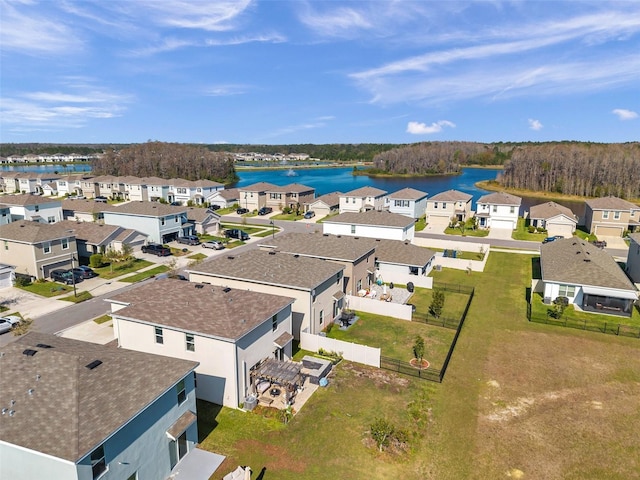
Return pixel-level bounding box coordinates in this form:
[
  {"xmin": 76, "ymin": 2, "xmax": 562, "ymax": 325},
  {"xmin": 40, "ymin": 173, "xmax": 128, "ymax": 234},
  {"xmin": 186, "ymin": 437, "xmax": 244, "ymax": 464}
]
[{"xmin": 0, "ymin": 332, "xmax": 198, "ymax": 462}]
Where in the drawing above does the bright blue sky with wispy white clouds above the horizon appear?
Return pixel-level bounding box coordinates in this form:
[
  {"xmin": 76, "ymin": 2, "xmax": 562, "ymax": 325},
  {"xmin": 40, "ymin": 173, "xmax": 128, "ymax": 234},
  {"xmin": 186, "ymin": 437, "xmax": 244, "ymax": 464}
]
[{"xmin": 0, "ymin": 0, "xmax": 640, "ymax": 144}]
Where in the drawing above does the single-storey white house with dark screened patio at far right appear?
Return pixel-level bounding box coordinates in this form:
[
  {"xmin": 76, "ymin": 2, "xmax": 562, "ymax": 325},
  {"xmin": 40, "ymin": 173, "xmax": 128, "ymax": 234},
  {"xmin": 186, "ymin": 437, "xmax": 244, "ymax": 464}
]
[{"xmin": 540, "ymin": 237, "xmax": 638, "ymax": 317}]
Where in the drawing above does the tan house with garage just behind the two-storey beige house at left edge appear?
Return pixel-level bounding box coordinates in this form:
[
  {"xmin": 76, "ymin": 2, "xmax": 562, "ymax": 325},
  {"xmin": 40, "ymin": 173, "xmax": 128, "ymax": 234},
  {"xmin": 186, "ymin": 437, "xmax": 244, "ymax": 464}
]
[{"xmin": 61, "ymin": 220, "xmax": 147, "ymax": 258}]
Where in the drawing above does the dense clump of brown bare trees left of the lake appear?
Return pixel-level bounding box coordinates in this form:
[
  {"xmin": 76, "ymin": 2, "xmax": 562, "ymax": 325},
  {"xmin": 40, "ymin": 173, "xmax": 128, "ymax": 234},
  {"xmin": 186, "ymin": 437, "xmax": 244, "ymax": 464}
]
[{"xmin": 91, "ymin": 142, "xmax": 238, "ymax": 184}]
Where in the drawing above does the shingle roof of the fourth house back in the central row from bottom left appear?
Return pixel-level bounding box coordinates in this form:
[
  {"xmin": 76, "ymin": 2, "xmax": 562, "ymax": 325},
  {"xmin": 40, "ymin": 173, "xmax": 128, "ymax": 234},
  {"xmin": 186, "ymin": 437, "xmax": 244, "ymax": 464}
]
[{"xmin": 260, "ymin": 233, "xmax": 373, "ymax": 262}]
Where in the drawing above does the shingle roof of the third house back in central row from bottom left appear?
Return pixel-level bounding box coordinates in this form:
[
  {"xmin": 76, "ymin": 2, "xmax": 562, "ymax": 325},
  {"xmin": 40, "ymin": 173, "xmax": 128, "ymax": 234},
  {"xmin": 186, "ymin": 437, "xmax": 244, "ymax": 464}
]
[{"xmin": 191, "ymin": 250, "xmax": 344, "ymax": 290}]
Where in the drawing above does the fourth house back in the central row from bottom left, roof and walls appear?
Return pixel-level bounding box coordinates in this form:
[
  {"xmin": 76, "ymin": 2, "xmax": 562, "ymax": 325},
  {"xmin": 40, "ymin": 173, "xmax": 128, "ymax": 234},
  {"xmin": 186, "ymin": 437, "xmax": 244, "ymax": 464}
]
[{"xmin": 259, "ymin": 233, "xmax": 375, "ymax": 295}]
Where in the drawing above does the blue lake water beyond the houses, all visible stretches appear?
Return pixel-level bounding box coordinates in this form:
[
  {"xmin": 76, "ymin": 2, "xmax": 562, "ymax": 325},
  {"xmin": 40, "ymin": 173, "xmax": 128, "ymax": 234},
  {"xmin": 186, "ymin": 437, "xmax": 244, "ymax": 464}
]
[{"xmin": 0, "ymin": 164, "xmax": 584, "ymax": 219}]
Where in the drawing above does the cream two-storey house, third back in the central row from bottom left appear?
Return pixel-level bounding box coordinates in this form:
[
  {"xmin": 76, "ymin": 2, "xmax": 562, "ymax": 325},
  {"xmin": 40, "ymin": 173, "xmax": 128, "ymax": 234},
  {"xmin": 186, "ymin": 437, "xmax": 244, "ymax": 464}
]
[{"xmin": 189, "ymin": 250, "xmax": 344, "ymax": 339}]
